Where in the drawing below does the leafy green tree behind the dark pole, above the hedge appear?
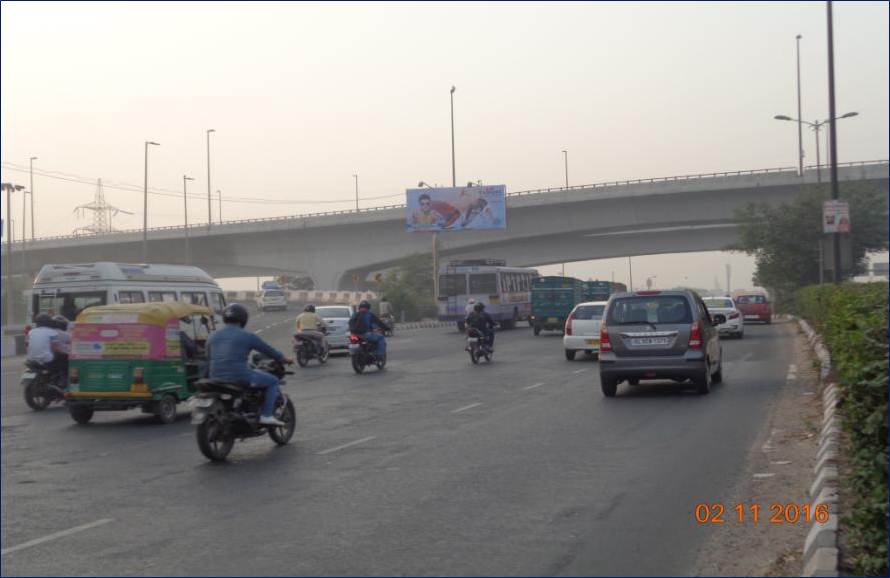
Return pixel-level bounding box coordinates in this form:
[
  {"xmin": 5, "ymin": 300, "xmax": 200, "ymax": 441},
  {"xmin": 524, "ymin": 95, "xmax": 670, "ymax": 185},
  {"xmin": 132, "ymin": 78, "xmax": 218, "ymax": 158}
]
[{"xmin": 730, "ymin": 182, "xmax": 888, "ymax": 304}]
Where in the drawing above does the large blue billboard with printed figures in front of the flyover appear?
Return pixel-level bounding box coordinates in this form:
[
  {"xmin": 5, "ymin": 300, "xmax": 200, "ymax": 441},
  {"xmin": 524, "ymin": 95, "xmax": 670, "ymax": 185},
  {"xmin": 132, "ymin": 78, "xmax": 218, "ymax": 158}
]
[{"xmin": 405, "ymin": 185, "xmax": 507, "ymax": 233}]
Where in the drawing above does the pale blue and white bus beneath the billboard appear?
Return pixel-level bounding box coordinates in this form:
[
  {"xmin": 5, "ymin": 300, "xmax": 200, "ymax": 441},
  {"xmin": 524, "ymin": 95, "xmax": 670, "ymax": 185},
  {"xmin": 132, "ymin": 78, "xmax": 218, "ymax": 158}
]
[{"xmin": 438, "ymin": 259, "xmax": 538, "ymax": 331}]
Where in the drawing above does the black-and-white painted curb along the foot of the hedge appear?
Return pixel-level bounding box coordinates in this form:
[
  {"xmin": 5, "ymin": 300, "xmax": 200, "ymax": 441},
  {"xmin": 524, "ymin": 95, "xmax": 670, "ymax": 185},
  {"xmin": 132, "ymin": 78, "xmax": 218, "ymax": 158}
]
[{"xmin": 797, "ymin": 319, "xmax": 841, "ymax": 576}]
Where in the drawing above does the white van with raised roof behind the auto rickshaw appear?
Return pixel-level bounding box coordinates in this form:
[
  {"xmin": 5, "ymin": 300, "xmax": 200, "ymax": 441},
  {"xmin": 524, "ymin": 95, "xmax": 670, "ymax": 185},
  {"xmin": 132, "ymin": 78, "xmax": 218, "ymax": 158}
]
[{"xmin": 29, "ymin": 262, "xmax": 226, "ymax": 321}]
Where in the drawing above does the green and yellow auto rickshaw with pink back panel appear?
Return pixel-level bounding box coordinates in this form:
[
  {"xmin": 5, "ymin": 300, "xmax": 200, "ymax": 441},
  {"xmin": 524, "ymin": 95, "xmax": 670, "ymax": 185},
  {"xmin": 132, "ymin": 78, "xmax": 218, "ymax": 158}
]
[{"xmin": 65, "ymin": 301, "xmax": 214, "ymax": 424}]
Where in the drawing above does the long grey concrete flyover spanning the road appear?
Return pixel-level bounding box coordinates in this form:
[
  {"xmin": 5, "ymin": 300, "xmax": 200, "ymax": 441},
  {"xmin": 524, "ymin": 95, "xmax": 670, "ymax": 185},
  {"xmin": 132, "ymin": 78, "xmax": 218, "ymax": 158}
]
[{"xmin": 3, "ymin": 160, "xmax": 888, "ymax": 290}]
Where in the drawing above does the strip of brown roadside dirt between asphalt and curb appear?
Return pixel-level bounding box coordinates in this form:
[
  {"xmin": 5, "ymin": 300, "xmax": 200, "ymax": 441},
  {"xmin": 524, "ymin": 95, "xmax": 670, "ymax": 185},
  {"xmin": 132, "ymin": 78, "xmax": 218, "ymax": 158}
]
[{"xmin": 692, "ymin": 320, "xmax": 822, "ymax": 576}]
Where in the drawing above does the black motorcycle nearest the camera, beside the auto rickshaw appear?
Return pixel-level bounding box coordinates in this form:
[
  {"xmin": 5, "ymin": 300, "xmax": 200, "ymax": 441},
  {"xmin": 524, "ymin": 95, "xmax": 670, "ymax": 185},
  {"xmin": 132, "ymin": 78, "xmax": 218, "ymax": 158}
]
[{"xmin": 190, "ymin": 354, "xmax": 297, "ymax": 462}]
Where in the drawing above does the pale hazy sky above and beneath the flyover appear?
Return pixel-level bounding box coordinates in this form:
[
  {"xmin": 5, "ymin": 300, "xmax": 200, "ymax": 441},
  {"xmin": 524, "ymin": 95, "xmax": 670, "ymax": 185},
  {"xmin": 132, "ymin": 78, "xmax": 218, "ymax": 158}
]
[{"xmin": 0, "ymin": 1, "xmax": 890, "ymax": 287}]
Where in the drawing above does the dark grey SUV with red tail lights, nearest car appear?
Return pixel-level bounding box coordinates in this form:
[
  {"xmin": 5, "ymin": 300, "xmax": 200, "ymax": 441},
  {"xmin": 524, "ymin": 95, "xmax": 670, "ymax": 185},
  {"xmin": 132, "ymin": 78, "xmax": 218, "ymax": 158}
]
[{"xmin": 599, "ymin": 290, "xmax": 726, "ymax": 397}]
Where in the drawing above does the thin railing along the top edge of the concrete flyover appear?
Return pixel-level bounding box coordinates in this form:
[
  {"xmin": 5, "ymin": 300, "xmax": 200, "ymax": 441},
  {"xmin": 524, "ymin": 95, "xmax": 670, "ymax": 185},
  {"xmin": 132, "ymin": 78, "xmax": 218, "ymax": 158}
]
[{"xmin": 10, "ymin": 159, "xmax": 888, "ymax": 245}]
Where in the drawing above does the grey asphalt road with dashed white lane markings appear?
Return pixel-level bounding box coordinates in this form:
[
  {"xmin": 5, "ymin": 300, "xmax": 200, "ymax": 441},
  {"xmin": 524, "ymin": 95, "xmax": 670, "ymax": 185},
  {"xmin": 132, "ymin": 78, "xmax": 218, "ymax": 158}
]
[{"xmin": 2, "ymin": 313, "xmax": 793, "ymax": 576}]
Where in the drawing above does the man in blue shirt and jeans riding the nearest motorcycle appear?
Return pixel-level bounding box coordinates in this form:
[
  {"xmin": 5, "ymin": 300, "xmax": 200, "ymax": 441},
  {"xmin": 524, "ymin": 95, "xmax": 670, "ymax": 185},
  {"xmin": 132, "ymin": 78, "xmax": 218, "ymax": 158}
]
[{"xmin": 207, "ymin": 303, "xmax": 293, "ymax": 427}]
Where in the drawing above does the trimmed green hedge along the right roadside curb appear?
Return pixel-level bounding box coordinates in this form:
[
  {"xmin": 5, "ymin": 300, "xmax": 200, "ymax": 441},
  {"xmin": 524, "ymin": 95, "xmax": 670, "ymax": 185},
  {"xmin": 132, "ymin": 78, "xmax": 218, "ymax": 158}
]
[{"xmin": 795, "ymin": 283, "xmax": 888, "ymax": 576}]
